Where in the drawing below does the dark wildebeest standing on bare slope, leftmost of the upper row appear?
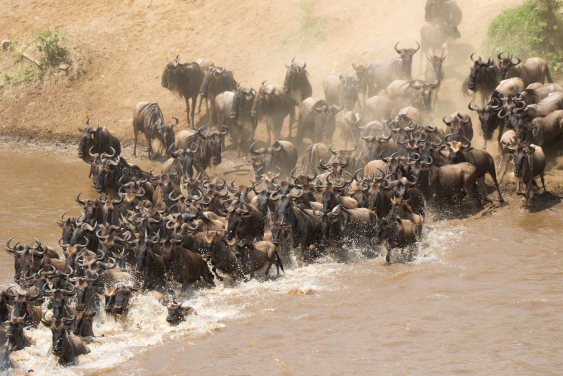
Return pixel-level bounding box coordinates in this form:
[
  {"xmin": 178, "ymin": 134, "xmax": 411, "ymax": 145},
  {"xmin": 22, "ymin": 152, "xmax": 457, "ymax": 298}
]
[{"xmin": 161, "ymin": 55, "xmax": 204, "ymax": 128}]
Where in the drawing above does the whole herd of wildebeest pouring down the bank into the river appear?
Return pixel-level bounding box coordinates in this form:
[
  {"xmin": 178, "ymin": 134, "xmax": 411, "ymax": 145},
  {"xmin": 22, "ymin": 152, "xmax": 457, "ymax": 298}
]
[{"xmin": 0, "ymin": 0, "xmax": 563, "ymax": 368}]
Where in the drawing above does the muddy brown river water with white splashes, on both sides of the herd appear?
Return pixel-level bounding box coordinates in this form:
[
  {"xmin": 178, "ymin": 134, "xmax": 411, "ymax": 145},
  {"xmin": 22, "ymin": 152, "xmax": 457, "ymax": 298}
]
[{"xmin": 0, "ymin": 151, "xmax": 563, "ymax": 375}]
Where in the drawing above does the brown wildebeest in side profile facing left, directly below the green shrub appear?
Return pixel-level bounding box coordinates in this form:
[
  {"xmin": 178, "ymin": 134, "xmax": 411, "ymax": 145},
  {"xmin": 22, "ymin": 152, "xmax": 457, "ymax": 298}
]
[{"xmin": 498, "ymin": 52, "xmax": 553, "ymax": 86}]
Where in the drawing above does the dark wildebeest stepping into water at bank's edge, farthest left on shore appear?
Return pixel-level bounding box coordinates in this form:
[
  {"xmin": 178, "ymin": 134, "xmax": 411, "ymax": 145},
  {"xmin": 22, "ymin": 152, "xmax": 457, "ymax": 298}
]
[{"xmin": 78, "ymin": 119, "xmax": 121, "ymax": 162}]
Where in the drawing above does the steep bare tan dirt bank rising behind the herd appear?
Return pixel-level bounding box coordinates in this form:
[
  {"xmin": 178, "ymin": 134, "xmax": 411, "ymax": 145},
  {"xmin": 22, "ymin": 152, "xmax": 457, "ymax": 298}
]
[{"xmin": 0, "ymin": 0, "xmax": 528, "ymax": 147}]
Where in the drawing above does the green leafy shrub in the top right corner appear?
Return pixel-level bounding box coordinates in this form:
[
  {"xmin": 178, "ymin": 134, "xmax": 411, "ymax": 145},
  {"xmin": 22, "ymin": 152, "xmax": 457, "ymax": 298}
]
[{"xmin": 487, "ymin": 0, "xmax": 563, "ymax": 72}]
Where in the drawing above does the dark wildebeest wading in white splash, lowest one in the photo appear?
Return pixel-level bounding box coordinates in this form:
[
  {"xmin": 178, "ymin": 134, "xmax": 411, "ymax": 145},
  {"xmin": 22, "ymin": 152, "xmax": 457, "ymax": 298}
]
[{"xmin": 46, "ymin": 319, "xmax": 90, "ymax": 365}]
